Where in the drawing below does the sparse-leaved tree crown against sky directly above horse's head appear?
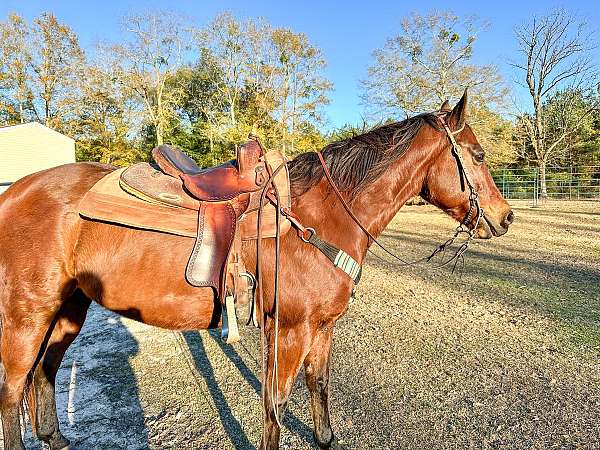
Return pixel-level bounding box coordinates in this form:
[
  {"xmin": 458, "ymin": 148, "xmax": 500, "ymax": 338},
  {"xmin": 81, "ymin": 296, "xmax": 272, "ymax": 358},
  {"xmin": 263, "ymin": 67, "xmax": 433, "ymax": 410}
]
[{"xmin": 361, "ymin": 12, "xmax": 507, "ymax": 116}]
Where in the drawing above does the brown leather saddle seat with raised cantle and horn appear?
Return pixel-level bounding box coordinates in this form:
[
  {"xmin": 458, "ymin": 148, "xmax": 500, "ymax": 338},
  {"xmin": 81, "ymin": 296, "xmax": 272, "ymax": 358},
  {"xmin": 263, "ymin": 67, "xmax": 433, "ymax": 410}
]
[{"xmin": 152, "ymin": 140, "xmax": 268, "ymax": 202}]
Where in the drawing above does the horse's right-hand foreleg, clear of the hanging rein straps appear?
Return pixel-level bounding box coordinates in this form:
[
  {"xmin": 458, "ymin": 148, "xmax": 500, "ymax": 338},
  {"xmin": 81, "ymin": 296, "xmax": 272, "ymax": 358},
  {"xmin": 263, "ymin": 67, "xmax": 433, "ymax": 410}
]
[{"xmin": 304, "ymin": 327, "xmax": 342, "ymax": 449}]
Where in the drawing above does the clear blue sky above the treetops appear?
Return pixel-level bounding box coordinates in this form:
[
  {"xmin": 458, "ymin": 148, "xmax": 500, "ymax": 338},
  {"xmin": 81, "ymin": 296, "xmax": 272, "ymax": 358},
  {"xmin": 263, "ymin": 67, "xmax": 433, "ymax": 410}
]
[{"xmin": 0, "ymin": 0, "xmax": 600, "ymax": 126}]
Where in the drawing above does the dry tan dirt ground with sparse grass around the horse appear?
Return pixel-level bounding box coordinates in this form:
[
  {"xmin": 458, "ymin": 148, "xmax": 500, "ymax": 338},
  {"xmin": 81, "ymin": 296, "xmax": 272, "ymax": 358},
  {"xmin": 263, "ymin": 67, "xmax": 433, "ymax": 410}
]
[{"xmin": 5, "ymin": 202, "xmax": 600, "ymax": 450}]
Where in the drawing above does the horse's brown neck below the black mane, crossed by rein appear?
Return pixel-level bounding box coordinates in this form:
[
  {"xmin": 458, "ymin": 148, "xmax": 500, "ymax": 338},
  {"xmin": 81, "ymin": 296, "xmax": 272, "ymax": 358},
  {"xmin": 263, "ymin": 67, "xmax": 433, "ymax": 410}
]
[{"xmin": 297, "ymin": 139, "xmax": 432, "ymax": 262}]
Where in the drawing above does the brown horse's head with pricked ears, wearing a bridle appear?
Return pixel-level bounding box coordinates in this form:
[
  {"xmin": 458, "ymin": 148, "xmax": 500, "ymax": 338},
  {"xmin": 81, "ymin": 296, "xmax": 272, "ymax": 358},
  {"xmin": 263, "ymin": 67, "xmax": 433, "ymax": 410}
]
[{"xmin": 421, "ymin": 91, "xmax": 514, "ymax": 239}]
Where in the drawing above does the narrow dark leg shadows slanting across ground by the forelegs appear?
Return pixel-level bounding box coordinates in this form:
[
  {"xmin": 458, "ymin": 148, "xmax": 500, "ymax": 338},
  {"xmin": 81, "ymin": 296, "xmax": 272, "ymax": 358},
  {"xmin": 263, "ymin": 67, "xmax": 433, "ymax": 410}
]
[{"xmin": 183, "ymin": 330, "xmax": 313, "ymax": 450}]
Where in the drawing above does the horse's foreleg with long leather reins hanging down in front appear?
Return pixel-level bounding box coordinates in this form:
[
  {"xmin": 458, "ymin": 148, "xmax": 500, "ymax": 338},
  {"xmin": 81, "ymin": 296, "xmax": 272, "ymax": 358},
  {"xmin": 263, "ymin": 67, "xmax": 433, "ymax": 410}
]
[{"xmin": 260, "ymin": 321, "xmax": 310, "ymax": 450}]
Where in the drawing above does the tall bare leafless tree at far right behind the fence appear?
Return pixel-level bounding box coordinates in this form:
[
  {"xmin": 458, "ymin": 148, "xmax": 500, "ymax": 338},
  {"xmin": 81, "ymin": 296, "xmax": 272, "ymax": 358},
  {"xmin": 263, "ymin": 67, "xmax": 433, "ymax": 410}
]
[{"xmin": 512, "ymin": 10, "xmax": 600, "ymax": 198}]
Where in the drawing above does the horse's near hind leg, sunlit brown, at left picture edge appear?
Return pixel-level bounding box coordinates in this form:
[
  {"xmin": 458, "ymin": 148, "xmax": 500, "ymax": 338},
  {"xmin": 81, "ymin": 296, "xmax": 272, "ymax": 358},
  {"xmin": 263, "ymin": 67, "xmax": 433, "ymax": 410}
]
[{"xmin": 0, "ymin": 308, "xmax": 56, "ymax": 450}]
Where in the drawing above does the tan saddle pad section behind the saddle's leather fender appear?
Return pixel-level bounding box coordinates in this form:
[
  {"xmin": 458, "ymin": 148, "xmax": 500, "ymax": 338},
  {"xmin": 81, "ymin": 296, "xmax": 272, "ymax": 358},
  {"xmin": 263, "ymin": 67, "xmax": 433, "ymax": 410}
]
[{"xmin": 79, "ymin": 169, "xmax": 198, "ymax": 238}]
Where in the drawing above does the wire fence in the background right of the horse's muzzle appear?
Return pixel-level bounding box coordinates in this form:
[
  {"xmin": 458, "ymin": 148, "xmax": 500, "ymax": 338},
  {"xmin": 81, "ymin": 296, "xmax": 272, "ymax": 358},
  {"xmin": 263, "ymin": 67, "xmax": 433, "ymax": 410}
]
[{"xmin": 492, "ymin": 166, "xmax": 600, "ymax": 205}]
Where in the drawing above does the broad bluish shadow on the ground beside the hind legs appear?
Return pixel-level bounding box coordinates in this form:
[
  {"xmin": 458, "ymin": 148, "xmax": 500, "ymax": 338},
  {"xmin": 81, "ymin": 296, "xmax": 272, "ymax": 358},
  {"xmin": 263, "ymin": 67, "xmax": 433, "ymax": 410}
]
[{"xmin": 25, "ymin": 305, "xmax": 149, "ymax": 450}]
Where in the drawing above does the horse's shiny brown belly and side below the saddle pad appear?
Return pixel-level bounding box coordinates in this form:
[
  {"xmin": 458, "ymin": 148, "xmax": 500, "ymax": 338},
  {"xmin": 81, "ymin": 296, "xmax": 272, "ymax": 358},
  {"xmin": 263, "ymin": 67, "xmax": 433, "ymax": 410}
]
[{"xmin": 75, "ymin": 221, "xmax": 221, "ymax": 330}]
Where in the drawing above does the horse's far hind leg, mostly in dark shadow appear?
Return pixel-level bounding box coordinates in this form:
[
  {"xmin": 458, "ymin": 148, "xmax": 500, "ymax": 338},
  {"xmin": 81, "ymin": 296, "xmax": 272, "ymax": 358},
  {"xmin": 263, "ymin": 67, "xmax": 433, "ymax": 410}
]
[{"xmin": 28, "ymin": 290, "xmax": 91, "ymax": 450}]
